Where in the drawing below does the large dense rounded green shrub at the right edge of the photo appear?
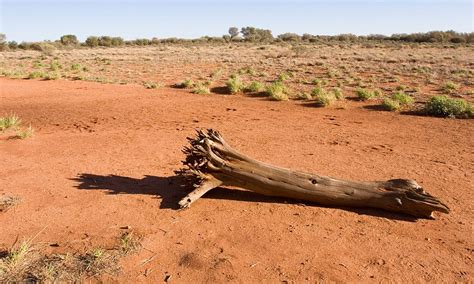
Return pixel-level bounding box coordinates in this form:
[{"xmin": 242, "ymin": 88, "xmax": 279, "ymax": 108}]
[{"xmin": 424, "ymin": 96, "xmax": 474, "ymax": 117}]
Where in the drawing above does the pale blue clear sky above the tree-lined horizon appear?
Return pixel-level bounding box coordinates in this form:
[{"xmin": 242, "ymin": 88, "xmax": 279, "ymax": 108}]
[{"xmin": 0, "ymin": 0, "xmax": 474, "ymax": 42}]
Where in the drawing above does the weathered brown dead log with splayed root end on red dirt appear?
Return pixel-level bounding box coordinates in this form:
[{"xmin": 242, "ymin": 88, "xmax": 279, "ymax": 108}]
[{"xmin": 176, "ymin": 129, "xmax": 449, "ymax": 218}]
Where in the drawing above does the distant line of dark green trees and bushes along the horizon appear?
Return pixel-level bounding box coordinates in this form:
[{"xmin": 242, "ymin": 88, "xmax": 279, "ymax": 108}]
[{"xmin": 0, "ymin": 27, "xmax": 474, "ymax": 51}]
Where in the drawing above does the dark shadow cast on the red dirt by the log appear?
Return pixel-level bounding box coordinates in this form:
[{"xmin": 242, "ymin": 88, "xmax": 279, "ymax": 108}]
[{"xmin": 71, "ymin": 173, "xmax": 417, "ymax": 222}]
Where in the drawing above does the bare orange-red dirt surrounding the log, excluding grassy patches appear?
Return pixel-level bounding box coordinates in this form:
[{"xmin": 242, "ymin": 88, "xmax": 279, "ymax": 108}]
[{"xmin": 0, "ymin": 79, "xmax": 474, "ymax": 282}]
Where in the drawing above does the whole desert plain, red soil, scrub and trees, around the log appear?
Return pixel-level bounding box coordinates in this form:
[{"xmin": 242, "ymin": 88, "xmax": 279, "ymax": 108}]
[{"xmin": 0, "ymin": 27, "xmax": 474, "ymax": 283}]
